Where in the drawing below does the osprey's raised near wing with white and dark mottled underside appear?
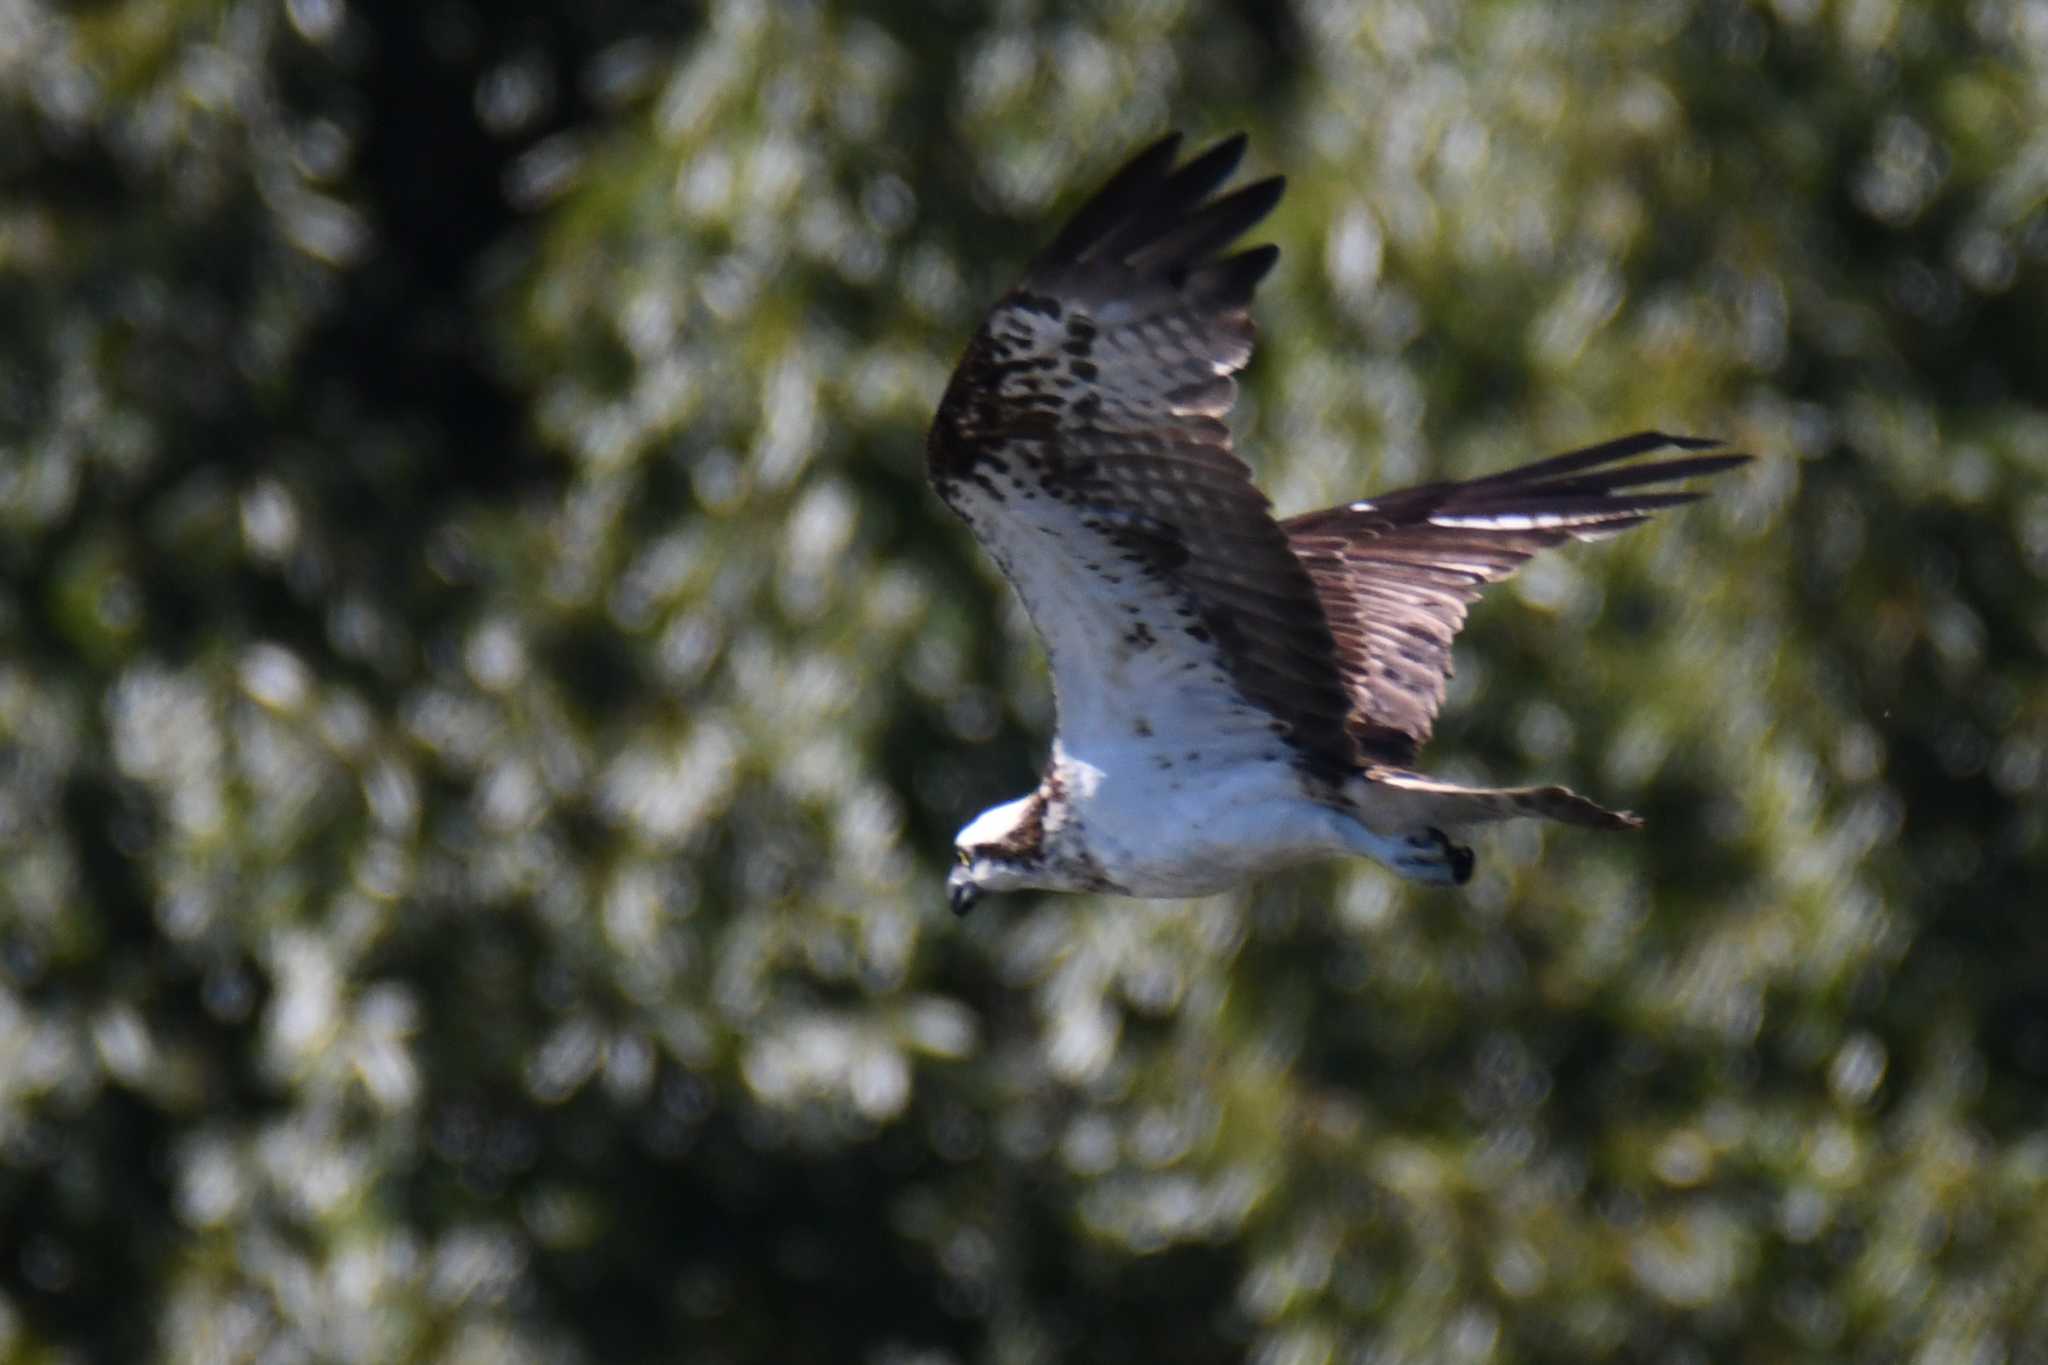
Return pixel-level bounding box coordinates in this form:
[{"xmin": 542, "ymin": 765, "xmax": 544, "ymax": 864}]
[{"xmin": 926, "ymin": 135, "xmax": 1356, "ymax": 776}]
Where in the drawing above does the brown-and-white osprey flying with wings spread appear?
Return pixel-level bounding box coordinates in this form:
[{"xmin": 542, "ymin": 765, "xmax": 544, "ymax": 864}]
[{"xmin": 926, "ymin": 133, "xmax": 1749, "ymax": 915}]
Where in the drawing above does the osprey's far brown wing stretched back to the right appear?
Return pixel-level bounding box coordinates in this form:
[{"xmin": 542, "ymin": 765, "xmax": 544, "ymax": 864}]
[{"xmin": 1282, "ymin": 432, "xmax": 1749, "ymax": 765}]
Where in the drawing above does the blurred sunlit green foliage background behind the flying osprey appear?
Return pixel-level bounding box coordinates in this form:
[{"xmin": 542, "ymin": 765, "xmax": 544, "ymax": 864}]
[{"xmin": 0, "ymin": 0, "xmax": 2048, "ymax": 1365}]
